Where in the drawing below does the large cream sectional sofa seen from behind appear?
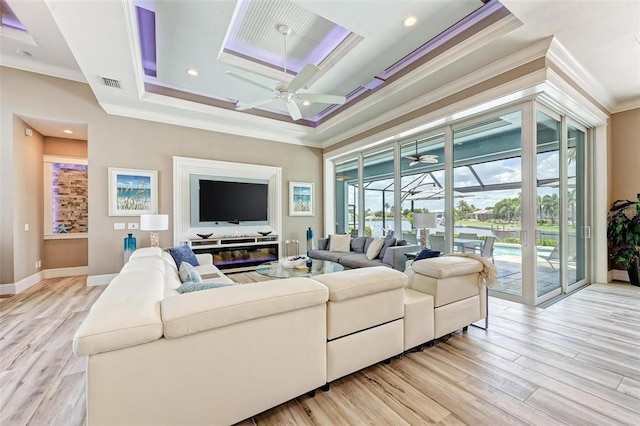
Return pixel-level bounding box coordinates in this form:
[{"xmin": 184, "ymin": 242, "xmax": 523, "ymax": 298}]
[{"xmin": 73, "ymin": 245, "xmax": 485, "ymax": 425}]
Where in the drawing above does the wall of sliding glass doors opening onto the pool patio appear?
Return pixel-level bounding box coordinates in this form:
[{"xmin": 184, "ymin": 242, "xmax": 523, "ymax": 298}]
[{"xmin": 334, "ymin": 102, "xmax": 590, "ymax": 304}]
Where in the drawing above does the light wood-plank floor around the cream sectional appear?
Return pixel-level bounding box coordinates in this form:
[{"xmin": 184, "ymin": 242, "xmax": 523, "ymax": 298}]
[{"xmin": 0, "ymin": 273, "xmax": 640, "ymax": 426}]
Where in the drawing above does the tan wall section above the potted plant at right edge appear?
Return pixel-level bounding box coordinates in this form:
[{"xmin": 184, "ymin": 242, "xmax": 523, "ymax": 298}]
[{"xmin": 610, "ymin": 108, "xmax": 640, "ymax": 202}]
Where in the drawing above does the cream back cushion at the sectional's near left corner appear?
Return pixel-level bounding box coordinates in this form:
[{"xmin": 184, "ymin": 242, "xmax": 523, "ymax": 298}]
[{"xmin": 73, "ymin": 270, "xmax": 164, "ymax": 356}]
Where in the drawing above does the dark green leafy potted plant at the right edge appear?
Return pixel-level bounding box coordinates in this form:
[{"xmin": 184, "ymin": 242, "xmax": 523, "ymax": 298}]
[{"xmin": 607, "ymin": 194, "xmax": 640, "ymax": 286}]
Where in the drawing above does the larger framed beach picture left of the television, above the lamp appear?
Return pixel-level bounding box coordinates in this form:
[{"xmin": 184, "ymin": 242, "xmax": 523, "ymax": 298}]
[{"xmin": 109, "ymin": 167, "xmax": 158, "ymax": 216}]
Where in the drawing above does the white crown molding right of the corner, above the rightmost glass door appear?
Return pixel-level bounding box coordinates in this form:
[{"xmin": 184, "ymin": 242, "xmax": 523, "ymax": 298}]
[{"xmin": 547, "ymin": 37, "xmax": 616, "ymax": 111}]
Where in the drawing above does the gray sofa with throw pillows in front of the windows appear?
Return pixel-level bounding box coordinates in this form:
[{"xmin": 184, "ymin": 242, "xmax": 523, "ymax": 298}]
[{"xmin": 309, "ymin": 237, "xmax": 420, "ymax": 271}]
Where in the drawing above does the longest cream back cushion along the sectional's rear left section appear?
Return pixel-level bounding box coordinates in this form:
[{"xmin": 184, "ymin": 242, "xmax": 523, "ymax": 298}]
[{"xmin": 162, "ymin": 278, "xmax": 329, "ymax": 338}]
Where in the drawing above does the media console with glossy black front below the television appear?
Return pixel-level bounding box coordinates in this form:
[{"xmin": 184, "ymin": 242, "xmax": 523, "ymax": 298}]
[{"xmin": 188, "ymin": 235, "xmax": 280, "ymax": 272}]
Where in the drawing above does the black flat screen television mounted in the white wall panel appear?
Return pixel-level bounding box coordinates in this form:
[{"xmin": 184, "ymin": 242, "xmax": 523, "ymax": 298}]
[{"xmin": 198, "ymin": 179, "xmax": 269, "ymax": 224}]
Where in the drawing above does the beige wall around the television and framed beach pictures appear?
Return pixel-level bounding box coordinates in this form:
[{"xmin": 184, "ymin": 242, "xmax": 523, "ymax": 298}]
[{"xmin": 0, "ymin": 68, "xmax": 323, "ymax": 283}]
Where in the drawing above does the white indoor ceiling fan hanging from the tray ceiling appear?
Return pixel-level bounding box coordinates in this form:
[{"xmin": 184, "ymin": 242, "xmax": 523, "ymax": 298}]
[{"xmin": 226, "ymin": 25, "xmax": 347, "ymax": 121}]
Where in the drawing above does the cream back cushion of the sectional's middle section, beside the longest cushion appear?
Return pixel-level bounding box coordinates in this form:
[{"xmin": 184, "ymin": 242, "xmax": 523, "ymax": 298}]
[{"xmin": 313, "ymin": 266, "xmax": 407, "ymax": 302}]
